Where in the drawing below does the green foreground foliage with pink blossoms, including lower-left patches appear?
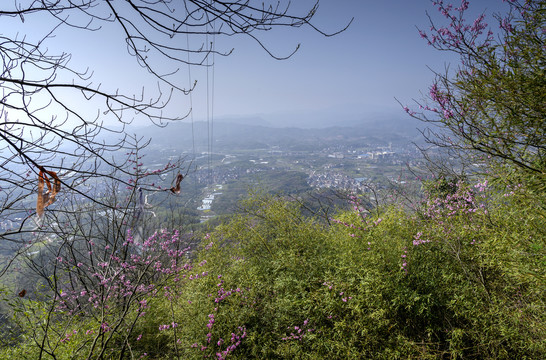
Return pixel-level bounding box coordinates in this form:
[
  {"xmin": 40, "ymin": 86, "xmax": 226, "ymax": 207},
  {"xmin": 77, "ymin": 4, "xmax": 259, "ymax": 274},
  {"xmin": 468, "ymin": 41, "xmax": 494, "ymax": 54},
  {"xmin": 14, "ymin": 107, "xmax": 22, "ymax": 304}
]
[{"xmin": 0, "ymin": 179, "xmax": 546, "ymax": 359}]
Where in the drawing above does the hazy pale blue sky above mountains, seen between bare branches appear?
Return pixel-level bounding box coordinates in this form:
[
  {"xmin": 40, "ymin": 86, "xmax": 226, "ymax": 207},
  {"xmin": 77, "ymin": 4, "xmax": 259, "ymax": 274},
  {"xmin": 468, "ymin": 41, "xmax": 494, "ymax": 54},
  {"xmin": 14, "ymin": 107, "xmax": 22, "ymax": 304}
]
[{"xmin": 5, "ymin": 0, "xmax": 502, "ymax": 127}]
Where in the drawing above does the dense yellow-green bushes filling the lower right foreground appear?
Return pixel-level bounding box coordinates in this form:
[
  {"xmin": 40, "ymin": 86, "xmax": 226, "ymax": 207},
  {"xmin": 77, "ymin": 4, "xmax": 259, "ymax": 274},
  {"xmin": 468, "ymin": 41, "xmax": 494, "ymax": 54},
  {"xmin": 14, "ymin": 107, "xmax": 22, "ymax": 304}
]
[{"xmin": 147, "ymin": 187, "xmax": 545, "ymax": 358}]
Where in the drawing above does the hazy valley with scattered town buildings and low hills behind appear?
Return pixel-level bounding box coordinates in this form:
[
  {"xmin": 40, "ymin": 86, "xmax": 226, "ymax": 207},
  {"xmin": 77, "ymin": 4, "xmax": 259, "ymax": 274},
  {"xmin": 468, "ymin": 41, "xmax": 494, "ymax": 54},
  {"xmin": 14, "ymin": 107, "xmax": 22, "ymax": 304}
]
[{"xmin": 0, "ymin": 124, "xmax": 452, "ymax": 231}]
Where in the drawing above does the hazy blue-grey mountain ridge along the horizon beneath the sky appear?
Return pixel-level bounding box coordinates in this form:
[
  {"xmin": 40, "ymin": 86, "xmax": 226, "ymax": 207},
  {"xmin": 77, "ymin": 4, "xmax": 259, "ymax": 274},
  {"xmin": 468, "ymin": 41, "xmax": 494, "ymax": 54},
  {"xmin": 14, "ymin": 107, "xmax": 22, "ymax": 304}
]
[{"xmin": 135, "ymin": 118, "xmax": 422, "ymax": 151}]
